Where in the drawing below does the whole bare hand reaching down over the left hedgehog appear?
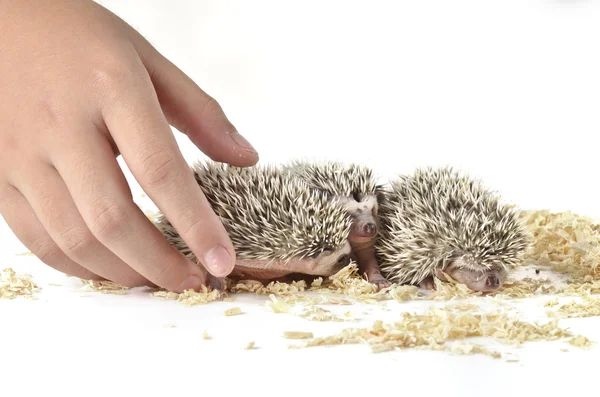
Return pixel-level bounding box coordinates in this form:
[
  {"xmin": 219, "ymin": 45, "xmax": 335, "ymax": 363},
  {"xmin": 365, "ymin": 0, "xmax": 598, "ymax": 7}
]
[{"xmin": 0, "ymin": 0, "xmax": 258, "ymax": 292}]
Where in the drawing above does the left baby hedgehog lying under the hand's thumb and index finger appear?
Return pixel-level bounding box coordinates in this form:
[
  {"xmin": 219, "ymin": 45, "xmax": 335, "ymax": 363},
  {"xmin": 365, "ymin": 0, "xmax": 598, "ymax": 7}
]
[{"xmin": 156, "ymin": 162, "xmax": 352, "ymax": 291}]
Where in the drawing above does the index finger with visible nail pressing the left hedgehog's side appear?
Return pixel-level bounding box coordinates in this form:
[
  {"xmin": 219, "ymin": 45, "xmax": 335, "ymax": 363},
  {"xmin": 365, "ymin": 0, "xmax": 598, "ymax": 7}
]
[{"xmin": 98, "ymin": 58, "xmax": 235, "ymax": 277}]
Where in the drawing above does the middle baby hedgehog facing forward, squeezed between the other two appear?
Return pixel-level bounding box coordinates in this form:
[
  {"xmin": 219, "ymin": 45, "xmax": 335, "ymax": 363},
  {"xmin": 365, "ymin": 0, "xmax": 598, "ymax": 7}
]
[{"xmin": 284, "ymin": 160, "xmax": 391, "ymax": 290}]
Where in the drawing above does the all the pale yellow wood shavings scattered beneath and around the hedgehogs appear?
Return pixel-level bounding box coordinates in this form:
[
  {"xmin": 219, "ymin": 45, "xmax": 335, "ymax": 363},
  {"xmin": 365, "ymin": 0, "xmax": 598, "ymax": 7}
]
[{"xmin": 0, "ymin": 210, "xmax": 600, "ymax": 361}]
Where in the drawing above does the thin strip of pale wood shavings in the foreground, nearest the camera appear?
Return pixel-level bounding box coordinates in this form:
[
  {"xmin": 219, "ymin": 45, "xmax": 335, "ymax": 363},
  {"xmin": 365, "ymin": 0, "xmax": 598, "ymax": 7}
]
[{"xmin": 296, "ymin": 307, "xmax": 591, "ymax": 357}]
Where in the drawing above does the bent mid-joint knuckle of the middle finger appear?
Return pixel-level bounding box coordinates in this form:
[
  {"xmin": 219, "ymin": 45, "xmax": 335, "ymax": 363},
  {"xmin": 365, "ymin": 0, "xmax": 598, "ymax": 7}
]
[{"xmin": 90, "ymin": 197, "xmax": 128, "ymax": 240}]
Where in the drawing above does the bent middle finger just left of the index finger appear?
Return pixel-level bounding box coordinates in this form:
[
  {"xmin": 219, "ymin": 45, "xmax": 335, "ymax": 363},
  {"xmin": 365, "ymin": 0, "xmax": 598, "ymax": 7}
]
[{"xmin": 52, "ymin": 125, "xmax": 211, "ymax": 292}]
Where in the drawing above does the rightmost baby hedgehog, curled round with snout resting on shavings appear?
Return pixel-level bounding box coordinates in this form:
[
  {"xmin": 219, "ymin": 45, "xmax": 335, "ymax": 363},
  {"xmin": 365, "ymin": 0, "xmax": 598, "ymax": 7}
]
[{"xmin": 376, "ymin": 164, "xmax": 529, "ymax": 292}]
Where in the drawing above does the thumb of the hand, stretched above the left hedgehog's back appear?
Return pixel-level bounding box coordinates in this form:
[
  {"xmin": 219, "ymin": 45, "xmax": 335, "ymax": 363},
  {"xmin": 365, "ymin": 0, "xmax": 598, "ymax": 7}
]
[{"xmin": 128, "ymin": 22, "xmax": 258, "ymax": 167}]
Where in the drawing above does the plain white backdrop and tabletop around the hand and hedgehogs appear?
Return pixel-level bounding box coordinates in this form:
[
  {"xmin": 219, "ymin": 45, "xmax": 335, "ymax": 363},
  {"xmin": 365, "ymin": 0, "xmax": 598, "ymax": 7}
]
[{"xmin": 0, "ymin": 0, "xmax": 600, "ymax": 396}]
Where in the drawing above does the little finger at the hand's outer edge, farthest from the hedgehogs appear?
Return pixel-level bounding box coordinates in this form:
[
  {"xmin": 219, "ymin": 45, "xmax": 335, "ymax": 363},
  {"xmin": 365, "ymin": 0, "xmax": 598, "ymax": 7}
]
[{"xmin": 0, "ymin": 186, "xmax": 102, "ymax": 280}]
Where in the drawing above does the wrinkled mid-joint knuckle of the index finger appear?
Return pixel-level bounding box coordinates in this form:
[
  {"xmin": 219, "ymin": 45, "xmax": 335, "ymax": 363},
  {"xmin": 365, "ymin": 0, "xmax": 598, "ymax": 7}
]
[{"xmin": 141, "ymin": 148, "xmax": 182, "ymax": 189}]
